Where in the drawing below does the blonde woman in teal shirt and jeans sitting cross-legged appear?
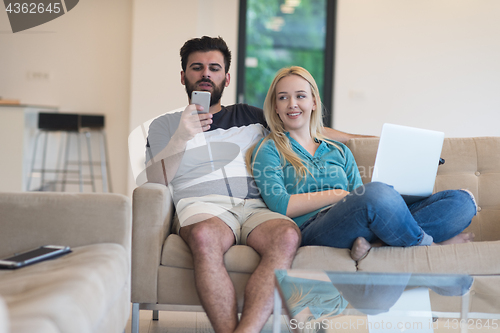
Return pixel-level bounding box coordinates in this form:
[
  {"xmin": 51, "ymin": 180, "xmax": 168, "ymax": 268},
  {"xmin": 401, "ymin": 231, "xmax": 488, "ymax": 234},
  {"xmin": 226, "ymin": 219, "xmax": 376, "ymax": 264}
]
[{"xmin": 247, "ymin": 67, "xmax": 477, "ymax": 260}]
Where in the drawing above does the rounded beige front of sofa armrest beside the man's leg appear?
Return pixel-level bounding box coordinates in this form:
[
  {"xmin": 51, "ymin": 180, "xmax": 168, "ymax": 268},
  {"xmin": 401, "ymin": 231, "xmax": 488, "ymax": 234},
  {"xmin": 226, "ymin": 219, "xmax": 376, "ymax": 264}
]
[{"xmin": 132, "ymin": 183, "xmax": 174, "ymax": 303}]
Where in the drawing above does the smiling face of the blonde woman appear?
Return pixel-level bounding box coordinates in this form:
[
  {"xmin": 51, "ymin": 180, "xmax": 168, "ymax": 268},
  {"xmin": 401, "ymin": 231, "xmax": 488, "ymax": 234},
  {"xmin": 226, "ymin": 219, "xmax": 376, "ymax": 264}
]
[{"xmin": 276, "ymin": 75, "xmax": 316, "ymax": 132}]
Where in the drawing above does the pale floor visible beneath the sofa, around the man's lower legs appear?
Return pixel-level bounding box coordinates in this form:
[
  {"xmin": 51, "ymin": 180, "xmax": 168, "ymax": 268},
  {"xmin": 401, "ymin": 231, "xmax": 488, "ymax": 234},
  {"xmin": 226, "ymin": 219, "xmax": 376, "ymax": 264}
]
[{"xmin": 125, "ymin": 310, "xmax": 290, "ymax": 333}]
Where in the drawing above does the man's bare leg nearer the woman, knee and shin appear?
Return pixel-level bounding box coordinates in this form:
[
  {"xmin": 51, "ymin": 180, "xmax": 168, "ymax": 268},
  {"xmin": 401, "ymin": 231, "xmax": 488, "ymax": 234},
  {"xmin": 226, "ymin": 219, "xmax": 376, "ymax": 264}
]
[{"xmin": 235, "ymin": 220, "xmax": 300, "ymax": 333}]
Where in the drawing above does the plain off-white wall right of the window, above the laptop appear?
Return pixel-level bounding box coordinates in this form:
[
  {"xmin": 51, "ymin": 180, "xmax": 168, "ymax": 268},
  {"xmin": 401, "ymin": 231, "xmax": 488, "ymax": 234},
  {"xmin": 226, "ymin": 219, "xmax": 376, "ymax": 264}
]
[{"xmin": 334, "ymin": 0, "xmax": 500, "ymax": 137}]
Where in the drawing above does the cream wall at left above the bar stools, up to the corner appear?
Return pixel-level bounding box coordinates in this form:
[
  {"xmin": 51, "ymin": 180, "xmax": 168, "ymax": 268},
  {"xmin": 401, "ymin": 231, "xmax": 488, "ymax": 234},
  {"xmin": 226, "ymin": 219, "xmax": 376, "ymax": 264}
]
[{"xmin": 0, "ymin": 0, "xmax": 132, "ymax": 194}]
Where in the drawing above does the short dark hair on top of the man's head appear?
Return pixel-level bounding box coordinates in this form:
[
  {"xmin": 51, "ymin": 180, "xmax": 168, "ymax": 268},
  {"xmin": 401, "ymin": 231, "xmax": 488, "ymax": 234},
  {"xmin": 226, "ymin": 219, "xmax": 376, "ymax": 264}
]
[{"xmin": 181, "ymin": 36, "xmax": 231, "ymax": 73}]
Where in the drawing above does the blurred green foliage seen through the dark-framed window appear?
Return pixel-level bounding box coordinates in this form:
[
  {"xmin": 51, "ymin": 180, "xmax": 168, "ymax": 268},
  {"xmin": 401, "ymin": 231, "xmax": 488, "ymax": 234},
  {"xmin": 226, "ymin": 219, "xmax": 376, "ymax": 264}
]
[{"xmin": 245, "ymin": 0, "xmax": 327, "ymax": 107}]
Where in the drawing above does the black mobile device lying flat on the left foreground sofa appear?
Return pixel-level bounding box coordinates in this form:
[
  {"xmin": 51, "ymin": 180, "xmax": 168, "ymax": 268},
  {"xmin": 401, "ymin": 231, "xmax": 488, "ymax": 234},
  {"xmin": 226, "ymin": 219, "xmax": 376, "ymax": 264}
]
[{"xmin": 0, "ymin": 245, "xmax": 71, "ymax": 268}]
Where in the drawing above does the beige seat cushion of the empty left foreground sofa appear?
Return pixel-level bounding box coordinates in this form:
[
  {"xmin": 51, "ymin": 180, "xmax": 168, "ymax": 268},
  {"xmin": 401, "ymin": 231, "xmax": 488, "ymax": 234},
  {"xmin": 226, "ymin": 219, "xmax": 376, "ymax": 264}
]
[{"xmin": 0, "ymin": 243, "xmax": 130, "ymax": 333}]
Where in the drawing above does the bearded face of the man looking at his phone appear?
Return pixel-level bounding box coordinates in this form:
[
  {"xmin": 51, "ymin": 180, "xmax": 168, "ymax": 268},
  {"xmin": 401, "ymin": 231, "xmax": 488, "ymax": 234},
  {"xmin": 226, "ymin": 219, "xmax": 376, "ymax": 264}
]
[{"xmin": 181, "ymin": 51, "xmax": 230, "ymax": 106}]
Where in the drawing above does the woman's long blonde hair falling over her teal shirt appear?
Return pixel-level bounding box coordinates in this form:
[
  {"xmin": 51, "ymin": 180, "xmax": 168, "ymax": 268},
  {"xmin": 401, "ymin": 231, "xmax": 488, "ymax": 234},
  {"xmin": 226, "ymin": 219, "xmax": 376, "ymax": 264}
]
[{"xmin": 246, "ymin": 66, "xmax": 343, "ymax": 183}]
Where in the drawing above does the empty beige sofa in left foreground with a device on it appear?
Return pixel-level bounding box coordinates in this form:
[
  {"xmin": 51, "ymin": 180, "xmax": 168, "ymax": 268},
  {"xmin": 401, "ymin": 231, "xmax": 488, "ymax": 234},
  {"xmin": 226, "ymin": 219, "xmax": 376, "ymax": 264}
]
[{"xmin": 0, "ymin": 192, "xmax": 132, "ymax": 333}]
